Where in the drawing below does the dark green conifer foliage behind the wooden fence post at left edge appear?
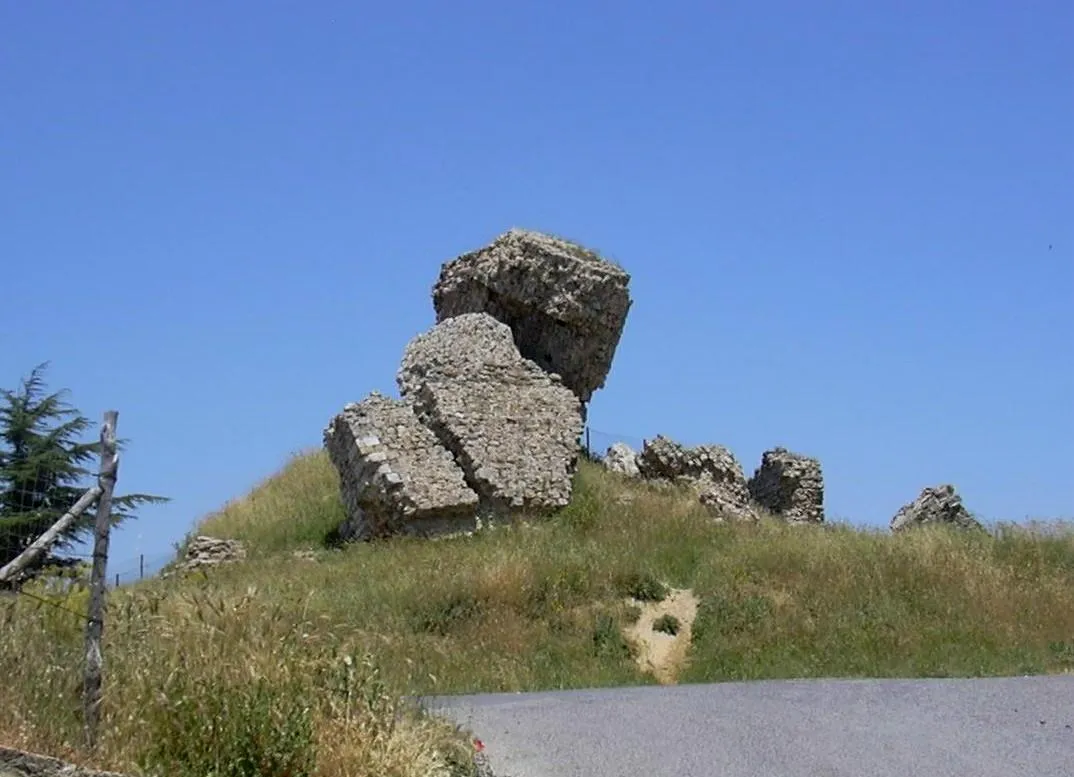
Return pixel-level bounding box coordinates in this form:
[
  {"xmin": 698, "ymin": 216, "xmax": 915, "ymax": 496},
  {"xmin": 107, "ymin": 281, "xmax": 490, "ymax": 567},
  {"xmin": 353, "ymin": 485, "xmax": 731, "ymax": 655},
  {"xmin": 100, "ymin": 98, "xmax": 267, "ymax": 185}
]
[{"xmin": 0, "ymin": 363, "xmax": 168, "ymax": 565}]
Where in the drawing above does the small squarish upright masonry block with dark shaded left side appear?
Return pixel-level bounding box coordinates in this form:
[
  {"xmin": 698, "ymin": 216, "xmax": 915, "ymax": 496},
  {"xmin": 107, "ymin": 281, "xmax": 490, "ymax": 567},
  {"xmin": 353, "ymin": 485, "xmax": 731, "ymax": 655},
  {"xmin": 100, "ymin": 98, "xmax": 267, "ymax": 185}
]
[{"xmin": 749, "ymin": 448, "xmax": 824, "ymax": 523}]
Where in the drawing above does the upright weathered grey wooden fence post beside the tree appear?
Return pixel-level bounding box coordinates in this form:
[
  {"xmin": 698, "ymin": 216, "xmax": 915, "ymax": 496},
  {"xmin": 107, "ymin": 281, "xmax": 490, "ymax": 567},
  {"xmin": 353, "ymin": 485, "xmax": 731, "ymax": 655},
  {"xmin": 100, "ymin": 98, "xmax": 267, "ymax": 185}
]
[{"xmin": 83, "ymin": 411, "xmax": 119, "ymax": 749}]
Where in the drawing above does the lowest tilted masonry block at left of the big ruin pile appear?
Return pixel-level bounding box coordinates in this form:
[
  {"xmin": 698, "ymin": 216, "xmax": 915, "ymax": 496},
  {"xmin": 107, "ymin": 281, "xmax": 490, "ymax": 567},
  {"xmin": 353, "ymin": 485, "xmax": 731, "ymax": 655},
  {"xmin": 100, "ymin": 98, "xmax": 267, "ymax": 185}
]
[{"xmin": 324, "ymin": 392, "xmax": 478, "ymax": 539}]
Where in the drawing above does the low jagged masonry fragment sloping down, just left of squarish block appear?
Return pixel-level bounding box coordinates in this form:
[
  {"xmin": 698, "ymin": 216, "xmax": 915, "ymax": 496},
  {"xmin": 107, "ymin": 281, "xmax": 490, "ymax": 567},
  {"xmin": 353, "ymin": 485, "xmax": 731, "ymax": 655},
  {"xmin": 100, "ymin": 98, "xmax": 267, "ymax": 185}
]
[{"xmin": 638, "ymin": 434, "xmax": 757, "ymax": 520}]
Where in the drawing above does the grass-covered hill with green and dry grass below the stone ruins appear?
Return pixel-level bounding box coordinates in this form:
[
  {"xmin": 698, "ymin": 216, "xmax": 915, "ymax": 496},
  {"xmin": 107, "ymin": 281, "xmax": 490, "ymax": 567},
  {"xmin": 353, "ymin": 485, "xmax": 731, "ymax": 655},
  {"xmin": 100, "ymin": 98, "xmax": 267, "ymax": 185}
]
[{"xmin": 0, "ymin": 452, "xmax": 1074, "ymax": 777}]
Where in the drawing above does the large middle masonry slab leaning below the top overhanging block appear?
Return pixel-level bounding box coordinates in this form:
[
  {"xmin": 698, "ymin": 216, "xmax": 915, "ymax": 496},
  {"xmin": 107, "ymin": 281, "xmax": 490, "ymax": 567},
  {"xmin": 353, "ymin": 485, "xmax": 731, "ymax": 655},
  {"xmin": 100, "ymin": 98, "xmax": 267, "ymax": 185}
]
[{"xmin": 396, "ymin": 313, "xmax": 582, "ymax": 510}]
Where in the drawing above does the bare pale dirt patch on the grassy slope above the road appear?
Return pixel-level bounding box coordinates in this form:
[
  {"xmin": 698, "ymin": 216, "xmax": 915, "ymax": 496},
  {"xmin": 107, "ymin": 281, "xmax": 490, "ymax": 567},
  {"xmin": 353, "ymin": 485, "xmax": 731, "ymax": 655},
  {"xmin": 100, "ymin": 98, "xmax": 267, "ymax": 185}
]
[{"xmin": 623, "ymin": 589, "xmax": 698, "ymax": 686}]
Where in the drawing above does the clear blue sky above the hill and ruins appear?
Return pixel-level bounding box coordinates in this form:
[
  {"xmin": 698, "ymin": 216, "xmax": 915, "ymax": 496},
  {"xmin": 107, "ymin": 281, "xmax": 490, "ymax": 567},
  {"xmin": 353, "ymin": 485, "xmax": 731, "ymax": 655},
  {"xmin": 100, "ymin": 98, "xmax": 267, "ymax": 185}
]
[{"xmin": 0, "ymin": 0, "xmax": 1074, "ymax": 572}]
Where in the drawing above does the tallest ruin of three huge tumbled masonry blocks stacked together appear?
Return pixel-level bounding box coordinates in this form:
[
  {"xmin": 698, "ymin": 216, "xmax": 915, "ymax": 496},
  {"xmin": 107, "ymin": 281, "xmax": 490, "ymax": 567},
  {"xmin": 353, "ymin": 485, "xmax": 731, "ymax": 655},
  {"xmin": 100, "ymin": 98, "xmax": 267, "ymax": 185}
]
[{"xmin": 323, "ymin": 230, "xmax": 630, "ymax": 538}]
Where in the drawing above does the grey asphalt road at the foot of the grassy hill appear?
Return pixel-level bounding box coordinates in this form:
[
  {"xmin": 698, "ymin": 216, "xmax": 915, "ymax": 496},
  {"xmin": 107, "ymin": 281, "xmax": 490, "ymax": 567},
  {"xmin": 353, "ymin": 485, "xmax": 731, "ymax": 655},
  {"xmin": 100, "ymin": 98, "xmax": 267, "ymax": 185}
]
[{"xmin": 424, "ymin": 675, "xmax": 1074, "ymax": 777}]
